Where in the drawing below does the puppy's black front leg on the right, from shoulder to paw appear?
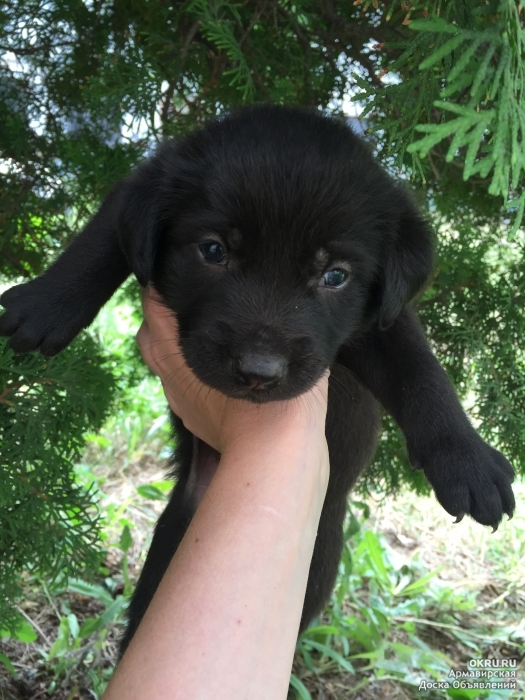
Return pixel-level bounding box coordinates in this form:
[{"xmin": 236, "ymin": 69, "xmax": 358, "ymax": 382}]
[{"xmin": 337, "ymin": 308, "xmax": 515, "ymax": 529}]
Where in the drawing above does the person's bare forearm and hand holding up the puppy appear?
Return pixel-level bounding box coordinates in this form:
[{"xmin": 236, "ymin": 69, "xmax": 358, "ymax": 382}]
[{"xmin": 109, "ymin": 289, "xmax": 329, "ymax": 700}]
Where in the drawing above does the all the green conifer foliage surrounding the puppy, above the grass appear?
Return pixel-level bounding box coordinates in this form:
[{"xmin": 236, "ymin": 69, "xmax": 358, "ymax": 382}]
[{"xmin": 0, "ymin": 0, "xmax": 525, "ymax": 628}]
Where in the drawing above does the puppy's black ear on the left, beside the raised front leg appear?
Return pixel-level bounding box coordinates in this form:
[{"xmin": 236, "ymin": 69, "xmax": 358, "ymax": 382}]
[{"xmin": 117, "ymin": 156, "xmax": 165, "ymax": 287}]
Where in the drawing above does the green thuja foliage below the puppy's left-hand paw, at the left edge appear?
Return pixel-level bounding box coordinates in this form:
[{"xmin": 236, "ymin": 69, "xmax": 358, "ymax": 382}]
[{"xmin": 0, "ymin": 335, "xmax": 114, "ymax": 628}]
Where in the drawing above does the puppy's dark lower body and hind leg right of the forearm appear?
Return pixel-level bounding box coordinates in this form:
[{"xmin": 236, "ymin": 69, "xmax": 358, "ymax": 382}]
[{"xmin": 300, "ymin": 365, "xmax": 379, "ymax": 631}]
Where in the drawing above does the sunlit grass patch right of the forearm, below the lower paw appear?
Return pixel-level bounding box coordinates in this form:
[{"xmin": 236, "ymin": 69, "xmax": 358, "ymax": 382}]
[{"xmin": 291, "ymin": 482, "xmax": 525, "ymax": 700}]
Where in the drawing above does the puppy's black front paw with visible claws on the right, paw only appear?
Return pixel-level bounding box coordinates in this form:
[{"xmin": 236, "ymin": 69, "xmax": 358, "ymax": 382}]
[{"xmin": 412, "ymin": 432, "xmax": 516, "ymax": 531}]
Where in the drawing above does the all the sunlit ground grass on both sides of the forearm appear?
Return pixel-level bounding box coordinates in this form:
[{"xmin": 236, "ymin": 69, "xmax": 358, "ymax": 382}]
[{"xmin": 0, "ymin": 298, "xmax": 525, "ymax": 700}]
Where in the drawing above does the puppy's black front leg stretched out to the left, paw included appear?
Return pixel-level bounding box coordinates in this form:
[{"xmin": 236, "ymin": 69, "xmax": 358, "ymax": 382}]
[{"xmin": 0, "ymin": 186, "xmax": 131, "ymax": 356}]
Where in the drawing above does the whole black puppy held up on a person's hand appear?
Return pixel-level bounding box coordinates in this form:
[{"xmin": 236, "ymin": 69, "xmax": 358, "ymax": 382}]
[{"xmin": 0, "ymin": 107, "xmax": 514, "ymax": 649}]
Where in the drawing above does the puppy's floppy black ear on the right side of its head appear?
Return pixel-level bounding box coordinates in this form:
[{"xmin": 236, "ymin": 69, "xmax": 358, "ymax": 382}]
[{"xmin": 379, "ymin": 202, "xmax": 434, "ymax": 330}]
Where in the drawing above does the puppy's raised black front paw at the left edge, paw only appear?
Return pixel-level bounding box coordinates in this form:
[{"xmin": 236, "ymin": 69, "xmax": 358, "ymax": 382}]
[{"xmin": 0, "ymin": 278, "xmax": 78, "ymax": 357}]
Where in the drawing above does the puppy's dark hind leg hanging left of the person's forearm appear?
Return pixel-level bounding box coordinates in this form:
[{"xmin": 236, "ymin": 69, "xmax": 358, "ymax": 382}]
[{"xmin": 120, "ymin": 413, "xmax": 219, "ymax": 656}]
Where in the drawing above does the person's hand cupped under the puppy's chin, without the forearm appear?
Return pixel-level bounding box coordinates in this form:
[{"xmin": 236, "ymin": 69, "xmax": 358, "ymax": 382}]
[{"xmin": 137, "ymin": 287, "xmax": 328, "ymax": 453}]
